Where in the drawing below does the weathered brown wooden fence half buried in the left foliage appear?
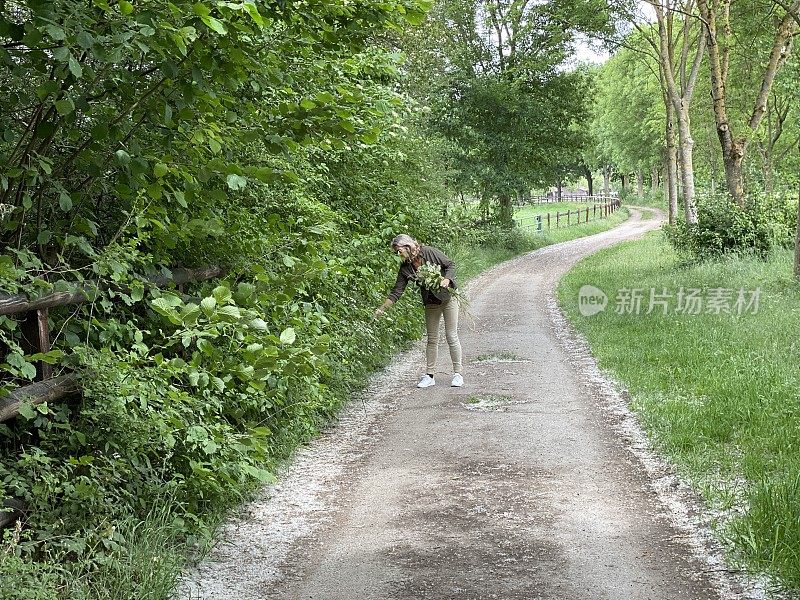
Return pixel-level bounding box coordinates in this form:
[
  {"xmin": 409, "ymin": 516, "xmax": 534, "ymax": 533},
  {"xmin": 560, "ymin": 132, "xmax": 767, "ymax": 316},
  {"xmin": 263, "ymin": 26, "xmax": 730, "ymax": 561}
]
[{"xmin": 0, "ymin": 267, "xmax": 225, "ymax": 529}]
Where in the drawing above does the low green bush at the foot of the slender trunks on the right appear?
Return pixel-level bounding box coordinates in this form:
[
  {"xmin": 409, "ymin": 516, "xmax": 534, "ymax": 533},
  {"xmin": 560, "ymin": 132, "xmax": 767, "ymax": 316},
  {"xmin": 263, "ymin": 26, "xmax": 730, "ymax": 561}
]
[{"xmin": 664, "ymin": 194, "xmax": 796, "ymax": 260}]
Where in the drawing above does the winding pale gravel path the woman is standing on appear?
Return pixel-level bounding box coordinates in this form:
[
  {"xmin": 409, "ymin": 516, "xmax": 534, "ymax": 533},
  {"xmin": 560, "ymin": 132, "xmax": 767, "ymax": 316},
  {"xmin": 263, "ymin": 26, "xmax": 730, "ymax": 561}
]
[{"xmin": 181, "ymin": 211, "xmax": 750, "ymax": 600}]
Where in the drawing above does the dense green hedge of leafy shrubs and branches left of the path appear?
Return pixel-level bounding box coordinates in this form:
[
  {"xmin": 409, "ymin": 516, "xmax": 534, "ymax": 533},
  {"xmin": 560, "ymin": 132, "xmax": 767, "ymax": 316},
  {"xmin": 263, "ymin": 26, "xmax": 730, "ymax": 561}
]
[{"xmin": 0, "ymin": 0, "xmax": 490, "ymax": 598}]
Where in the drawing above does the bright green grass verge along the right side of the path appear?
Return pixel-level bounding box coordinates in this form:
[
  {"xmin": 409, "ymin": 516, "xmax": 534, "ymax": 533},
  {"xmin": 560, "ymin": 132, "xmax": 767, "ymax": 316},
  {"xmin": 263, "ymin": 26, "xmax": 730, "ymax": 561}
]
[{"xmin": 558, "ymin": 232, "xmax": 800, "ymax": 590}]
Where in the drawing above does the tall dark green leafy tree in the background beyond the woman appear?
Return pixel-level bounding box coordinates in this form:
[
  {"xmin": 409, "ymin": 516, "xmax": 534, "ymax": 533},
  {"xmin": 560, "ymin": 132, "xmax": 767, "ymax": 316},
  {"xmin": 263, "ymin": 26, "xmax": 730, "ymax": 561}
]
[{"xmin": 410, "ymin": 0, "xmax": 603, "ymax": 223}]
